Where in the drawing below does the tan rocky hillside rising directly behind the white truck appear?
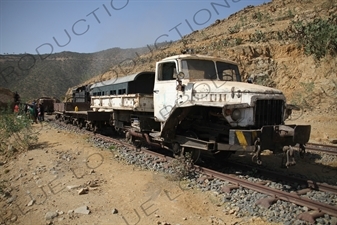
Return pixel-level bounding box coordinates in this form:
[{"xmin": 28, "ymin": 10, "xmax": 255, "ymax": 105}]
[{"xmin": 80, "ymin": 0, "xmax": 337, "ymax": 113}]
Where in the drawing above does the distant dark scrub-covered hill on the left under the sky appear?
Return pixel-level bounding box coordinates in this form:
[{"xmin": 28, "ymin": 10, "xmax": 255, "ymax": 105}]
[{"xmin": 0, "ymin": 48, "xmax": 154, "ymax": 100}]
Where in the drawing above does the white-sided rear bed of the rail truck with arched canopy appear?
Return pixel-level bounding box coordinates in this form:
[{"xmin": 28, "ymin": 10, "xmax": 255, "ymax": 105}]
[{"xmin": 90, "ymin": 71, "xmax": 160, "ymax": 131}]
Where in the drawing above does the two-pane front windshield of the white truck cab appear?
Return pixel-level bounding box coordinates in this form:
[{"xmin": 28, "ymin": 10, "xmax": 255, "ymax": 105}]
[{"xmin": 181, "ymin": 59, "xmax": 240, "ymax": 81}]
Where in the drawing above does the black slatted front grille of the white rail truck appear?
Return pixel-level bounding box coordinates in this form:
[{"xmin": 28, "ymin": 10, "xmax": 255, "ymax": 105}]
[{"xmin": 255, "ymin": 99, "xmax": 284, "ymax": 128}]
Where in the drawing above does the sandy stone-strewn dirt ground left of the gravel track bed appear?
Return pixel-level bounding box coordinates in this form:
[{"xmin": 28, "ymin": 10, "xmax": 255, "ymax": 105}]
[{"xmin": 0, "ymin": 126, "xmax": 276, "ymax": 225}]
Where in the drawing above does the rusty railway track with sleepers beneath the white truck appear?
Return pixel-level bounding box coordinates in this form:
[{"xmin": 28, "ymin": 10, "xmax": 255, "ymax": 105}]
[{"xmin": 99, "ymin": 132, "xmax": 337, "ymax": 223}]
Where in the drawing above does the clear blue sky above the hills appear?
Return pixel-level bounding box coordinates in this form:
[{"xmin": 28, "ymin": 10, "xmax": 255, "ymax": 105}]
[{"xmin": 0, "ymin": 0, "xmax": 270, "ymax": 54}]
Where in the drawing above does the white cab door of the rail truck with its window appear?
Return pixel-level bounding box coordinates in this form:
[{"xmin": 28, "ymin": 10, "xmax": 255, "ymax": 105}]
[{"xmin": 153, "ymin": 61, "xmax": 177, "ymax": 122}]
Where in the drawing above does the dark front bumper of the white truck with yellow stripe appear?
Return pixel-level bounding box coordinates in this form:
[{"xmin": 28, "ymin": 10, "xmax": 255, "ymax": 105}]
[{"xmin": 229, "ymin": 125, "xmax": 311, "ymax": 150}]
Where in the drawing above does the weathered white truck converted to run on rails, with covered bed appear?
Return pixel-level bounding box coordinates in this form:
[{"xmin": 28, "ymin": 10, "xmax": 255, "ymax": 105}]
[{"xmin": 54, "ymin": 54, "xmax": 311, "ymax": 166}]
